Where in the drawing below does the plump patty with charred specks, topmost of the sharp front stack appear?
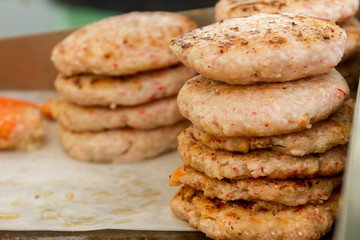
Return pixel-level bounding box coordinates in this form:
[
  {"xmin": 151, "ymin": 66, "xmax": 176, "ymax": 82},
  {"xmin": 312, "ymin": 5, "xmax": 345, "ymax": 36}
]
[{"xmin": 171, "ymin": 14, "xmax": 346, "ymax": 85}]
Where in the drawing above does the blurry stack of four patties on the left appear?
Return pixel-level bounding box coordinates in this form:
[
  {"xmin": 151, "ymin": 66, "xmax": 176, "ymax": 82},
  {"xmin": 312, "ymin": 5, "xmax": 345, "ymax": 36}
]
[{"xmin": 51, "ymin": 12, "xmax": 196, "ymax": 162}]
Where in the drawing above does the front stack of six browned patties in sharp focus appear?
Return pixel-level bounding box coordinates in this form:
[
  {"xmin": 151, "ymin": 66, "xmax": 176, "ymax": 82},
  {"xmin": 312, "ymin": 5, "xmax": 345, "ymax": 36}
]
[{"xmin": 170, "ymin": 14, "xmax": 353, "ymax": 239}]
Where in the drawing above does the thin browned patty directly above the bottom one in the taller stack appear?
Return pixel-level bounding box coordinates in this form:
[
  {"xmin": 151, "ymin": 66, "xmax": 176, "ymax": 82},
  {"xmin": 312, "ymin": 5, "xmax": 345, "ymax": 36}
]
[{"xmin": 169, "ymin": 166, "xmax": 342, "ymax": 206}]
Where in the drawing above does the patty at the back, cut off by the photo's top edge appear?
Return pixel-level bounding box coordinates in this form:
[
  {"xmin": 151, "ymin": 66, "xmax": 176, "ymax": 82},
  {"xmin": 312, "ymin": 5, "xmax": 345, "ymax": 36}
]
[{"xmin": 215, "ymin": 0, "xmax": 359, "ymax": 22}]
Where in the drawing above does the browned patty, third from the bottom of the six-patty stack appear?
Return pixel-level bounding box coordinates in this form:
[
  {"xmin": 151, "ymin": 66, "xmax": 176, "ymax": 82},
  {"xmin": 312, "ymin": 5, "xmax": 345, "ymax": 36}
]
[{"xmin": 178, "ymin": 130, "xmax": 347, "ymax": 180}]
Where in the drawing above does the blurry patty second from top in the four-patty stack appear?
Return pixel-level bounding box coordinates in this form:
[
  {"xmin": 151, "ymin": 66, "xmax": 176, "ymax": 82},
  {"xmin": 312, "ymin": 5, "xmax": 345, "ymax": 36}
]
[{"xmin": 55, "ymin": 64, "xmax": 196, "ymax": 107}]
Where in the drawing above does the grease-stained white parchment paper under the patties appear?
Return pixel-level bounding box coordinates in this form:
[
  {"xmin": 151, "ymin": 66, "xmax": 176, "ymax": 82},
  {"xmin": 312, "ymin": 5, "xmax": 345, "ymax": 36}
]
[{"xmin": 0, "ymin": 91, "xmax": 194, "ymax": 231}]
